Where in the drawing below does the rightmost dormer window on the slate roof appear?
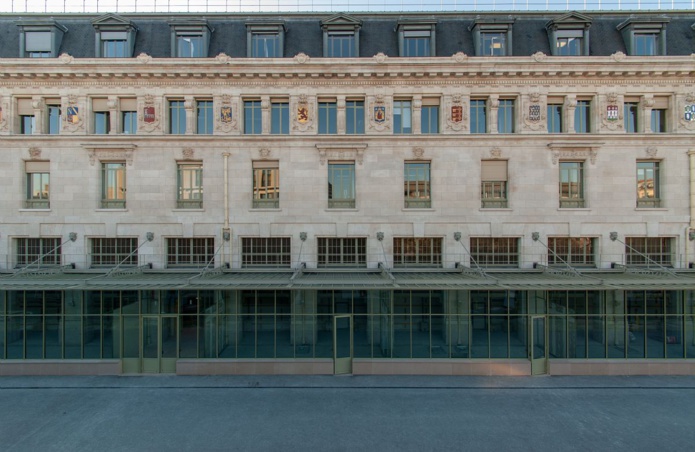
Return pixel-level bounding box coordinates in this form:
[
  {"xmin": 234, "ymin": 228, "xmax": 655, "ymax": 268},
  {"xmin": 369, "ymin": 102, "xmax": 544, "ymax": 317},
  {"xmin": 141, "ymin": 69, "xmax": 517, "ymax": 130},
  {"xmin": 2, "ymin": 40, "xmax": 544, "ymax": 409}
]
[{"xmin": 618, "ymin": 17, "xmax": 669, "ymax": 56}]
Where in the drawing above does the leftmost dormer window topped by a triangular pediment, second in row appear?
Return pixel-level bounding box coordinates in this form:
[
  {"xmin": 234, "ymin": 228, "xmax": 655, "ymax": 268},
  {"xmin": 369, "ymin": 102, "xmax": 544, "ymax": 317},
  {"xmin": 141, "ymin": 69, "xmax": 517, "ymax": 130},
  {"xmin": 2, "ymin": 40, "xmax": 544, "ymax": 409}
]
[{"xmin": 92, "ymin": 14, "xmax": 138, "ymax": 58}]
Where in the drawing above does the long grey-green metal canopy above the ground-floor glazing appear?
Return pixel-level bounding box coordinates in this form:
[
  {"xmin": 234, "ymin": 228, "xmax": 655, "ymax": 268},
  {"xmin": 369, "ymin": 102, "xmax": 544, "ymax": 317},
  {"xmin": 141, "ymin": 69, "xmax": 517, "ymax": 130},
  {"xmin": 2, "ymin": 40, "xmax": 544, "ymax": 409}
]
[{"xmin": 0, "ymin": 269, "xmax": 695, "ymax": 290}]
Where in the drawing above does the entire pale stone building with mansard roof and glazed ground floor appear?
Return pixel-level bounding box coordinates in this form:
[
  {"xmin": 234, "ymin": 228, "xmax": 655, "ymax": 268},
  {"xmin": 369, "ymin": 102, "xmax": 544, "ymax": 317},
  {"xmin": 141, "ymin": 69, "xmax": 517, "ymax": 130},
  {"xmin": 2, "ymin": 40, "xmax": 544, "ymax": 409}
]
[{"xmin": 0, "ymin": 12, "xmax": 695, "ymax": 374}]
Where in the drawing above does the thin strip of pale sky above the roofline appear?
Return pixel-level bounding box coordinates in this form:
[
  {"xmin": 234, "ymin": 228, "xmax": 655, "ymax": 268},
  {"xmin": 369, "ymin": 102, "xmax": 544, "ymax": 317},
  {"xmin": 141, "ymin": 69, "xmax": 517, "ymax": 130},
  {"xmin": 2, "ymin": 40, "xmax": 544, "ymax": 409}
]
[{"xmin": 0, "ymin": 0, "xmax": 695, "ymax": 13}]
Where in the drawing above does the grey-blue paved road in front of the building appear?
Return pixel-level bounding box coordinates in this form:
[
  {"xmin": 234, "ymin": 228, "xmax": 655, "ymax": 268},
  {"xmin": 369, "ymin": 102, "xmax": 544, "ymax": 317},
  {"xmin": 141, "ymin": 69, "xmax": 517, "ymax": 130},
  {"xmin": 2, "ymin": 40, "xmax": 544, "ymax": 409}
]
[{"xmin": 0, "ymin": 376, "xmax": 695, "ymax": 452}]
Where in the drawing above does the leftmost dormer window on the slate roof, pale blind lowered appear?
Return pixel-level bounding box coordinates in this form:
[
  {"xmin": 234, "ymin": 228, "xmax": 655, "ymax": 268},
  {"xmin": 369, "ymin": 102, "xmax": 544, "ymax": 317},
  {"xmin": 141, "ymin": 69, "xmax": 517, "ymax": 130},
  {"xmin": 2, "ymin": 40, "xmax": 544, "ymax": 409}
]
[{"xmin": 17, "ymin": 20, "xmax": 68, "ymax": 58}]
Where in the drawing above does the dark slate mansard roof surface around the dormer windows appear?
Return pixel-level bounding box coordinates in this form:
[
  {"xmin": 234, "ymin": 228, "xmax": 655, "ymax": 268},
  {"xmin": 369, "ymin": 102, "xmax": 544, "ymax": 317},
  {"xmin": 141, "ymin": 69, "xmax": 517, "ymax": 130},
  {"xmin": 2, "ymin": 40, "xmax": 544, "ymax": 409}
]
[{"xmin": 0, "ymin": 11, "xmax": 695, "ymax": 58}]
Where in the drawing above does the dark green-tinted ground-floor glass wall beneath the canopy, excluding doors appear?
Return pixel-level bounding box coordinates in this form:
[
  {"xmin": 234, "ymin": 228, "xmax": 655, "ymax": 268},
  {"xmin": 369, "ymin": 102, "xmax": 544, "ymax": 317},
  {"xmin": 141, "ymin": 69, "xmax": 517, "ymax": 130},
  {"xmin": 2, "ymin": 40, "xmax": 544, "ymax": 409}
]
[{"xmin": 0, "ymin": 290, "xmax": 695, "ymax": 360}]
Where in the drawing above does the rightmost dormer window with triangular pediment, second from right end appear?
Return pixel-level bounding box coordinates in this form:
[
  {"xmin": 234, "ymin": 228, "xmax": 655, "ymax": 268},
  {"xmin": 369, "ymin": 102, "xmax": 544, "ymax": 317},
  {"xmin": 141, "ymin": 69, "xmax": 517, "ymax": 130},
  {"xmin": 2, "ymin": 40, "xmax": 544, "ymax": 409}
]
[{"xmin": 545, "ymin": 12, "xmax": 591, "ymax": 56}]
